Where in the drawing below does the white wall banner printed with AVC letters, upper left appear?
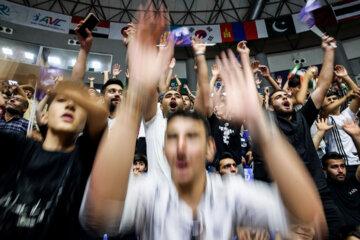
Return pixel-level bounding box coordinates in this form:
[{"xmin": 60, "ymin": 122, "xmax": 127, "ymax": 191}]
[{"xmin": 26, "ymin": 8, "xmax": 71, "ymax": 33}]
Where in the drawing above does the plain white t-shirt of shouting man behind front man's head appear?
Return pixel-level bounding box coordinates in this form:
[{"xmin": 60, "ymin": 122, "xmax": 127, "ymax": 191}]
[{"xmin": 144, "ymin": 104, "xmax": 171, "ymax": 179}]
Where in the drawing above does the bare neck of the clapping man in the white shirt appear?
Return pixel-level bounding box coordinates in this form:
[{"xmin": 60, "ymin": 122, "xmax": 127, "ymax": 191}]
[{"xmin": 175, "ymin": 171, "xmax": 206, "ymax": 219}]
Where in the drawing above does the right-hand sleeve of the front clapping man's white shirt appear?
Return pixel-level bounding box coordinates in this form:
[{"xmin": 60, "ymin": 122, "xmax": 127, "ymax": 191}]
[{"xmin": 226, "ymin": 176, "xmax": 288, "ymax": 236}]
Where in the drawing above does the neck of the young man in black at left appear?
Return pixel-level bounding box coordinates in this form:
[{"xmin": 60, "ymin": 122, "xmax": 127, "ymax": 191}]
[{"xmin": 43, "ymin": 129, "xmax": 76, "ymax": 152}]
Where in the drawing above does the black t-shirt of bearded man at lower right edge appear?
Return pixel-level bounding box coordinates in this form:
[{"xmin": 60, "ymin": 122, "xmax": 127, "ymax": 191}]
[{"xmin": 328, "ymin": 175, "xmax": 360, "ymax": 226}]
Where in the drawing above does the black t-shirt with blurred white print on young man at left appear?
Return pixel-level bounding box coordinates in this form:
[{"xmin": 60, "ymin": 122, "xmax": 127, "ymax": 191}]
[{"xmin": 0, "ymin": 130, "xmax": 98, "ymax": 239}]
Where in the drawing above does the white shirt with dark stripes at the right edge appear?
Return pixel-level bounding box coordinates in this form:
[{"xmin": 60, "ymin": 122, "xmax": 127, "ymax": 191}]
[{"xmin": 324, "ymin": 107, "xmax": 360, "ymax": 166}]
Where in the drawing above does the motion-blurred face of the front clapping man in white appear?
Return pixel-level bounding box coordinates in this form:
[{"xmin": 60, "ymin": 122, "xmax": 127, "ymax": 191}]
[{"xmin": 164, "ymin": 116, "xmax": 210, "ymax": 186}]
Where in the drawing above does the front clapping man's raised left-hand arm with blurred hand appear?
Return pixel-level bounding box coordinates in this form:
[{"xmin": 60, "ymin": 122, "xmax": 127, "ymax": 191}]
[{"xmin": 81, "ymin": 5, "xmax": 172, "ymax": 233}]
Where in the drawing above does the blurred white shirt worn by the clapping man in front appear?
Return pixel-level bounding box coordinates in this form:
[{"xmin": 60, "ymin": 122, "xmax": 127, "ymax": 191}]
[{"xmin": 120, "ymin": 174, "xmax": 288, "ymax": 240}]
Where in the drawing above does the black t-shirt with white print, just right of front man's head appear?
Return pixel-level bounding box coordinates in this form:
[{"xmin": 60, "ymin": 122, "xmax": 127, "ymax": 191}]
[{"xmin": 209, "ymin": 114, "xmax": 241, "ymax": 164}]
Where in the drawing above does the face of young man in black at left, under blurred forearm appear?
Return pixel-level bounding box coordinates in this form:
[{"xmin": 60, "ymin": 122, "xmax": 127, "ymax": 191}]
[{"xmin": 45, "ymin": 95, "xmax": 87, "ymax": 134}]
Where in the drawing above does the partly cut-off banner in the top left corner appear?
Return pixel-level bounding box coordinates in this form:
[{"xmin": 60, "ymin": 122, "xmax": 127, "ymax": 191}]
[{"xmin": 0, "ymin": 0, "xmax": 29, "ymax": 25}]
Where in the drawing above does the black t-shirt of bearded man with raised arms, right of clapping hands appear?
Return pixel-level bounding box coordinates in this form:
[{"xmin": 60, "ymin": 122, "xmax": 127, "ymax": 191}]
[{"xmin": 253, "ymin": 97, "xmax": 327, "ymax": 191}]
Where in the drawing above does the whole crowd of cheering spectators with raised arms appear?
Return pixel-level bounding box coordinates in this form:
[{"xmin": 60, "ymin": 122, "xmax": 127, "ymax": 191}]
[{"xmin": 0, "ymin": 3, "xmax": 360, "ymax": 240}]
